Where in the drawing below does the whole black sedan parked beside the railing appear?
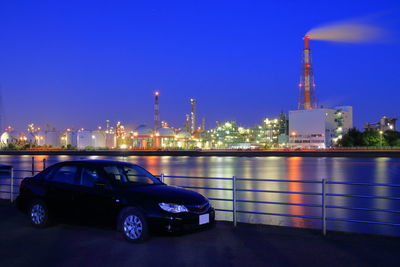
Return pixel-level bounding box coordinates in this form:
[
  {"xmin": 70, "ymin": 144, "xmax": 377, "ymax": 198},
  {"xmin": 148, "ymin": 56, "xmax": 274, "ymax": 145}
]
[{"xmin": 17, "ymin": 160, "xmax": 215, "ymax": 242}]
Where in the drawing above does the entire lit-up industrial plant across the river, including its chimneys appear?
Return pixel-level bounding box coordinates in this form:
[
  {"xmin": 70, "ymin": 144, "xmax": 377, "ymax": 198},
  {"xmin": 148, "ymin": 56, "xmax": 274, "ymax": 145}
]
[{"xmin": 0, "ymin": 36, "xmax": 396, "ymax": 150}]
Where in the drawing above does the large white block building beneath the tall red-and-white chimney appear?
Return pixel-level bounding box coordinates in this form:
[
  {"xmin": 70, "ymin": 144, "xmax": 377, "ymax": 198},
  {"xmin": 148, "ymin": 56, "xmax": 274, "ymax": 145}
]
[{"xmin": 289, "ymin": 106, "xmax": 353, "ymax": 148}]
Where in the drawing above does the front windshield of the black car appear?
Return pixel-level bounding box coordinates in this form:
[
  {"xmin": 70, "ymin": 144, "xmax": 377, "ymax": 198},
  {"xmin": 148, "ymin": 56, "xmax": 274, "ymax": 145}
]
[{"xmin": 104, "ymin": 165, "xmax": 161, "ymax": 185}]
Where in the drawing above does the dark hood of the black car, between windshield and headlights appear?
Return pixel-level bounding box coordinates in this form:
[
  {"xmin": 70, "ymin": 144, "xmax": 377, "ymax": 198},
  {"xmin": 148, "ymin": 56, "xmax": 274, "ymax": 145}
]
[{"xmin": 124, "ymin": 185, "xmax": 207, "ymax": 205}]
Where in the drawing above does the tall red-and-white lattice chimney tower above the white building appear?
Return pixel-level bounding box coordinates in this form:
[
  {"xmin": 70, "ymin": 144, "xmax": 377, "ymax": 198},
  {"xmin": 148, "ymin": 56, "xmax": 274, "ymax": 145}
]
[{"xmin": 298, "ymin": 36, "xmax": 317, "ymax": 109}]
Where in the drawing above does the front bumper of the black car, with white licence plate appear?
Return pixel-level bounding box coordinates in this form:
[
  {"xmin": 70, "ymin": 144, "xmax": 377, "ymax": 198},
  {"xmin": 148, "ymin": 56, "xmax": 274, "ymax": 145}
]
[{"xmin": 149, "ymin": 208, "xmax": 215, "ymax": 232}]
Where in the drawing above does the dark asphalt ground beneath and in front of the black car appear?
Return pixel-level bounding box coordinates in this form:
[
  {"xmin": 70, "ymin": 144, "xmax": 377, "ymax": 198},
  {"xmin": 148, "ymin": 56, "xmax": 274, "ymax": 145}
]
[{"xmin": 0, "ymin": 201, "xmax": 400, "ymax": 267}]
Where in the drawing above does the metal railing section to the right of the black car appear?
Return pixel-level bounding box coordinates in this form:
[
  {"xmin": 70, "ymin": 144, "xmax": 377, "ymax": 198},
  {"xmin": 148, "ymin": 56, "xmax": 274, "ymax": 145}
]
[{"xmin": 159, "ymin": 174, "xmax": 400, "ymax": 235}]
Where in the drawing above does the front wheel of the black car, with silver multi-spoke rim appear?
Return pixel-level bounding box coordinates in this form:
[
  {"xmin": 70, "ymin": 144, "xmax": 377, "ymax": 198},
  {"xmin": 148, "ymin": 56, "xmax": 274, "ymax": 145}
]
[{"xmin": 118, "ymin": 207, "xmax": 149, "ymax": 243}]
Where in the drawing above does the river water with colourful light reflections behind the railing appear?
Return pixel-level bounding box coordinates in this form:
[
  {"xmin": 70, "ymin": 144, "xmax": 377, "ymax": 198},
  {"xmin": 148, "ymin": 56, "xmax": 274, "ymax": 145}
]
[{"xmin": 0, "ymin": 155, "xmax": 400, "ymax": 236}]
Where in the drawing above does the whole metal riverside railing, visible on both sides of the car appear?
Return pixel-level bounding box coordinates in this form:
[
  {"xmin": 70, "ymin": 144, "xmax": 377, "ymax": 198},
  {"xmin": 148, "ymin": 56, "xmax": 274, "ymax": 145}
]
[{"xmin": 0, "ymin": 168, "xmax": 400, "ymax": 235}]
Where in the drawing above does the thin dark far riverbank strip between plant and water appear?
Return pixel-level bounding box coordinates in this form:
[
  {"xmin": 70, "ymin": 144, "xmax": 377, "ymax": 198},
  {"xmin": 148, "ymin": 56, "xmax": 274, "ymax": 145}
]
[{"xmin": 0, "ymin": 149, "xmax": 400, "ymax": 158}]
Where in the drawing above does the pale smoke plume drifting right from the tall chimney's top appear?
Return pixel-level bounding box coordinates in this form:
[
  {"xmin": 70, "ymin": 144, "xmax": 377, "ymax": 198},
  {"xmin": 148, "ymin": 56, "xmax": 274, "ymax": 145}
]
[{"xmin": 306, "ymin": 20, "xmax": 387, "ymax": 43}]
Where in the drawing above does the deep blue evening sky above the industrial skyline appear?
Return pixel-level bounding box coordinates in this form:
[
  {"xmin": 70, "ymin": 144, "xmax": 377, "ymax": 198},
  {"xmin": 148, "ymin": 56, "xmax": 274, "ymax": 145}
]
[{"xmin": 0, "ymin": 0, "xmax": 400, "ymax": 130}]
